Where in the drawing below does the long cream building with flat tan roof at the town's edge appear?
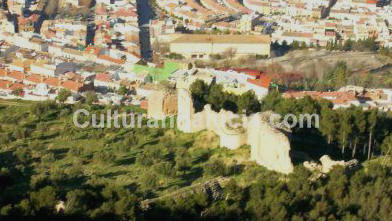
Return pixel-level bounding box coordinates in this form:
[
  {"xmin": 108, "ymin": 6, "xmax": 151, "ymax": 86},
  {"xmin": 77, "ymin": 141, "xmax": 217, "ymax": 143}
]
[{"xmin": 170, "ymin": 34, "xmax": 271, "ymax": 59}]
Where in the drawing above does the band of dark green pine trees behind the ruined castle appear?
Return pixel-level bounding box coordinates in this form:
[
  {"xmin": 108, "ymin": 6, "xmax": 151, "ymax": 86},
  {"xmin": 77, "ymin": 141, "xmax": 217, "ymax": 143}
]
[{"xmin": 190, "ymin": 79, "xmax": 392, "ymax": 159}]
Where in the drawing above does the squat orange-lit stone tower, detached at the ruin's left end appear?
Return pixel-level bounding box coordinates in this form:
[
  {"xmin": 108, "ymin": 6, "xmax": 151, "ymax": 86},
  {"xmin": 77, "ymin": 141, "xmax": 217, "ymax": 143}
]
[{"xmin": 147, "ymin": 91, "xmax": 177, "ymax": 120}]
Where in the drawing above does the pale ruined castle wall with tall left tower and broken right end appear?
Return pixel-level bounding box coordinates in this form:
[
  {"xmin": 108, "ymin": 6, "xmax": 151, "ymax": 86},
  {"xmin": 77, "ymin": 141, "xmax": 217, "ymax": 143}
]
[{"xmin": 177, "ymin": 78, "xmax": 294, "ymax": 174}]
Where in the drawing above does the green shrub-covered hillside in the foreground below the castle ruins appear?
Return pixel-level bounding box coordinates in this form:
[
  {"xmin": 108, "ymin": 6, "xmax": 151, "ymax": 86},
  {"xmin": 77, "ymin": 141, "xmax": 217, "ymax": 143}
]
[{"xmin": 0, "ymin": 99, "xmax": 392, "ymax": 220}]
